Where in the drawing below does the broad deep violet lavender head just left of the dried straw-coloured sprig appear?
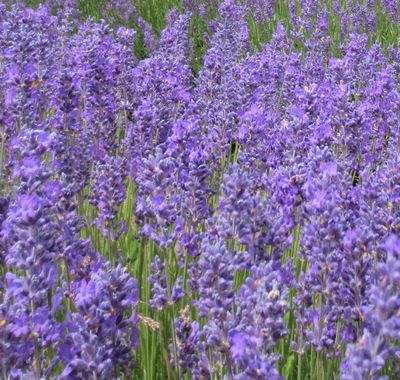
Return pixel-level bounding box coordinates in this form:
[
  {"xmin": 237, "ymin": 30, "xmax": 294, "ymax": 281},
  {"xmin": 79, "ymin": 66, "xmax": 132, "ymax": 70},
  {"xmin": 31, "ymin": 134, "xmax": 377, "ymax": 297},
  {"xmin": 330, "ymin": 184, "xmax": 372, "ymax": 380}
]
[{"xmin": 60, "ymin": 264, "xmax": 138, "ymax": 379}]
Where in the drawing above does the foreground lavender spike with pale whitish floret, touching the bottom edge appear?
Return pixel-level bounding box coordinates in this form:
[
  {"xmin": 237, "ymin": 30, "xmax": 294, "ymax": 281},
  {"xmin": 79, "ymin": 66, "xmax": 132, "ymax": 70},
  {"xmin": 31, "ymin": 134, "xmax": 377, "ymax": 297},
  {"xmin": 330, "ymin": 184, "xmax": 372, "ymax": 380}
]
[{"xmin": 229, "ymin": 263, "xmax": 291, "ymax": 379}]
